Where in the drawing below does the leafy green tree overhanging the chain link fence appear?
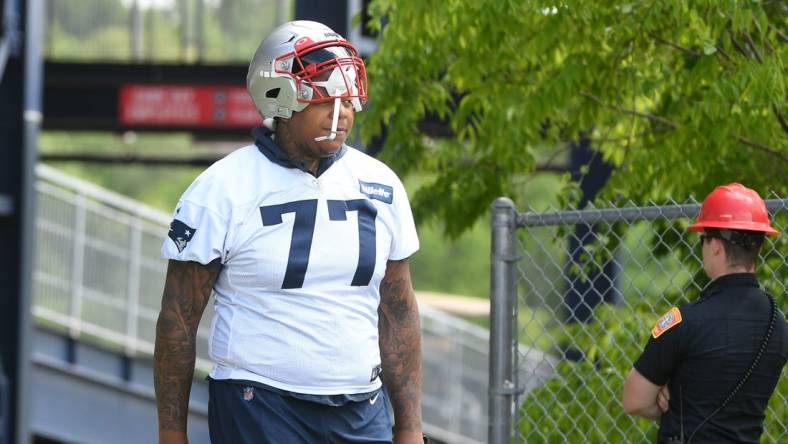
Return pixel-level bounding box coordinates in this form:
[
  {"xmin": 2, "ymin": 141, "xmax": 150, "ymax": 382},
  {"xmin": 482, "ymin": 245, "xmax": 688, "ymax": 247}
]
[{"xmin": 361, "ymin": 0, "xmax": 788, "ymax": 235}]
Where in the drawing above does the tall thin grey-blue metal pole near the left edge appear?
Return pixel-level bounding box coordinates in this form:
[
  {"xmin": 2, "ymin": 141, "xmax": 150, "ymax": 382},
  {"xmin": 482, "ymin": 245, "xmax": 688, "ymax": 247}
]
[{"xmin": 16, "ymin": 0, "xmax": 44, "ymax": 444}]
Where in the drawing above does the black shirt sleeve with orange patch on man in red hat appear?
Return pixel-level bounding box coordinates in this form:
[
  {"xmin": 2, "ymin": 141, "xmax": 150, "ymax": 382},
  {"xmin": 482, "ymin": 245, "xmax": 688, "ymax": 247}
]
[{"xmin": 634, "ymin": 309, "xmax": 686, "ymax": 386}]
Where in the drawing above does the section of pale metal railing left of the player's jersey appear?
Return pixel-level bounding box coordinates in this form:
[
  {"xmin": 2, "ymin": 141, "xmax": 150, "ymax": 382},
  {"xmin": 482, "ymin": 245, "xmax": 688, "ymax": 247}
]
[{"xmin": 32, "ymin": 165, "xmax": 213, "ymax": 372}]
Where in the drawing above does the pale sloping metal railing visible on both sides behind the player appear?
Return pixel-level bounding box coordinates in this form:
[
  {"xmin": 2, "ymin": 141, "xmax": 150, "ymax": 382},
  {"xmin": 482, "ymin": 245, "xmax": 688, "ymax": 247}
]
[{"xmin": 32, "ymin": 165, "xmax": 498, "ymax": 443}]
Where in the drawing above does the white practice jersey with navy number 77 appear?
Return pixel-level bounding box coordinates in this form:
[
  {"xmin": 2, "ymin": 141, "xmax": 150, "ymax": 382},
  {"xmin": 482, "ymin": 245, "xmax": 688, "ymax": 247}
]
[{"xmin": 162, "ymin": 140, "xmax": 419, "ymax": 395}]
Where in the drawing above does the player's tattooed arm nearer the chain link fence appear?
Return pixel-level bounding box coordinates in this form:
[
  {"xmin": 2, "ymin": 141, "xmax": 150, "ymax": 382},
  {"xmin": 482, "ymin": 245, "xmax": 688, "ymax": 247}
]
[{"xmin": 378, "ymin": 259, "xmax": 422, "ymax": 444}]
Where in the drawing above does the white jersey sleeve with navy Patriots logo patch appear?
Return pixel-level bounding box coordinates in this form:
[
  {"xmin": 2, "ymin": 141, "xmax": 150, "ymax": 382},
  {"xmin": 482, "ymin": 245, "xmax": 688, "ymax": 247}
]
[{"xmin": 161, "ymin": 174, "xmax": 230, "ymax": 265}]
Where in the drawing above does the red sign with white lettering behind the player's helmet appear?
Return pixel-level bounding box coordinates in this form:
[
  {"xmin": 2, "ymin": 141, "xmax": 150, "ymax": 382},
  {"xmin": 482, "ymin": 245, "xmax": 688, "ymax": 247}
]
[{"xmin": 118, "ymin": 85, "xmax": 262, "ymax": 128}]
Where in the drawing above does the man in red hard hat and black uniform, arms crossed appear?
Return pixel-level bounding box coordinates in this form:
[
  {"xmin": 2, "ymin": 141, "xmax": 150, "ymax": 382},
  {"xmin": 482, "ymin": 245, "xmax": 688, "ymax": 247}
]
[{"xmin": 623, "ymin": 183, "xmax": 788, "ymax": 444}]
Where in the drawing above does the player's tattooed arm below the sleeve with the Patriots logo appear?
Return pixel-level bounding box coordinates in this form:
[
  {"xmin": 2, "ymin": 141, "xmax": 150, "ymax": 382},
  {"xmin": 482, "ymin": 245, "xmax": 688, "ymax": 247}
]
[{"xmin": 153, "ymin": 259, "xmax": 221, "ymax": 444}]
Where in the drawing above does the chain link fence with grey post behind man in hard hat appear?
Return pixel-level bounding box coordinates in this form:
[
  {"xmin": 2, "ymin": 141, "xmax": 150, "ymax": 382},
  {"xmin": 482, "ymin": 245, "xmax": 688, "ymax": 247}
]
[{"xmin": 488, "ymin": 196, "xmax": 788, "ymax": 444}]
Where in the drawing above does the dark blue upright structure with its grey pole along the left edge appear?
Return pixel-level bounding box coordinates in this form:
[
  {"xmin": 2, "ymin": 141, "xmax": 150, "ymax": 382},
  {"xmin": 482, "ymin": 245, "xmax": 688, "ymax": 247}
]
[{"xmin": 0, "ymin": 0, "xmax": 38, "ymax": 444}]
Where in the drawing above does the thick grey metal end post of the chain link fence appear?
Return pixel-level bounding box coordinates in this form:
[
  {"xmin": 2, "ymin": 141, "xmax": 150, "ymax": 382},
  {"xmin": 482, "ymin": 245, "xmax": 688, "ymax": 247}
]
[{"xmin": 487, "ymin": 197, "xmax": 518, "ymax": 444}]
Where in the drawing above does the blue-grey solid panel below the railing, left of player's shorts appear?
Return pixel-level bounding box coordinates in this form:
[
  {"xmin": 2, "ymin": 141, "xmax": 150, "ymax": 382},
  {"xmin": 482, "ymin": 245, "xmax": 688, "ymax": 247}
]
[{"xmin": 30, "ymin": 327, "xmax": 210, "ymax": 444}]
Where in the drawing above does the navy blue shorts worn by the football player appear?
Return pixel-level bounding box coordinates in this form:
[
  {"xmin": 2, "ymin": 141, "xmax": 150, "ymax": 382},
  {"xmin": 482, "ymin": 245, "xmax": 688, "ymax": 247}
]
[{"xmin": 208, "ymin": 380, "xmax": 392, "ymax": 444}]
